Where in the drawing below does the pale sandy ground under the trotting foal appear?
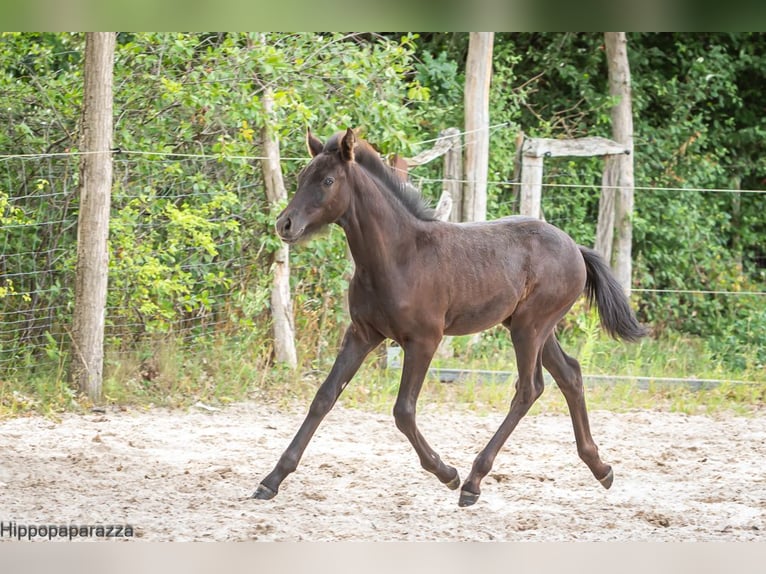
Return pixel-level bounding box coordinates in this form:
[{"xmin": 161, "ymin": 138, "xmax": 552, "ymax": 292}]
[{"xmin": 0, "ymin": 402, "xmax": 766, "ymax": 541}]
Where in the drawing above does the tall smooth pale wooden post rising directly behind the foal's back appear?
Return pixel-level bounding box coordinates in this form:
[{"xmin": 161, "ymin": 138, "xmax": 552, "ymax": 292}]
[{"xmin": 462, "ymin": 32, "xmax": 494, "ymax": 225}]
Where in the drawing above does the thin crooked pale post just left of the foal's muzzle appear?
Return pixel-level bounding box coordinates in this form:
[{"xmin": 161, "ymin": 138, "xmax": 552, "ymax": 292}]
[{"xmin": 261, "ymin": 88, "xmax": 298, "ymax": 369}]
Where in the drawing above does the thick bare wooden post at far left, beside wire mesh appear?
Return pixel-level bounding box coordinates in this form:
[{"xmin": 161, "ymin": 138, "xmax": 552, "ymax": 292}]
[{"xmin": 72, "ymin": 32, "xmax": 116, "ymax": 403}]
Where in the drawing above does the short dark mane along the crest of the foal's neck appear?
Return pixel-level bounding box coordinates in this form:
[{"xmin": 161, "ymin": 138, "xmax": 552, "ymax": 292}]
[{"xmin": 324, "ymin": 132, "xmax": 436, "ymax": 221}]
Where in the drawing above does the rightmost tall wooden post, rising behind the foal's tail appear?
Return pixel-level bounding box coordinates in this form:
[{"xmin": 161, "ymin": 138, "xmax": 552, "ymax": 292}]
[{"xmin": 604, "ymin": 32, "xmax": 634, "ymax": 295}]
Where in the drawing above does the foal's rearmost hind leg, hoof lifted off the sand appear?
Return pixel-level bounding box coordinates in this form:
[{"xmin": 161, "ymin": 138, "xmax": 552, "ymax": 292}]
[{"xmin": 542, "ymin": 334, "xmax": 614, "ymax": 488}]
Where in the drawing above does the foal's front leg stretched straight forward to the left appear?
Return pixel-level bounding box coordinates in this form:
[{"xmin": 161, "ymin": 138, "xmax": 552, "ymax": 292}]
[{"xmin": 252, "ymin": 324, "xmax": 383, "ymax": 500}]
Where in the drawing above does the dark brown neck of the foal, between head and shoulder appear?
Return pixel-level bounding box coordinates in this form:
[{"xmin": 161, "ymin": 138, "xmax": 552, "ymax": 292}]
[{"xmin": 339, "ymin": 170, "xmax": 420, "ymax": 272}]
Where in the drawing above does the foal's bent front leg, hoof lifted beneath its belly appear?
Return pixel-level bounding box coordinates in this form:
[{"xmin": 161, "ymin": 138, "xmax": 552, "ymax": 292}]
[{"xmin": 394, "ymin": 338, "xmax": 460, "ymax": 490}]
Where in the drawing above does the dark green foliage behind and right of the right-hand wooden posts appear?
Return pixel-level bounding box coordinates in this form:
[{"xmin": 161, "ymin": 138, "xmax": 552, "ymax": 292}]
[{"xmin": 490, "ymin": 33, "xmax": 766, "ymax": 365}]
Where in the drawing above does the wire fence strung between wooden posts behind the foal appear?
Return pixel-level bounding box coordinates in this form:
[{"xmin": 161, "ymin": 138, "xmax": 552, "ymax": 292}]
[{"xmin": 0, "ymin": 152, "xmax": 766, "ymax": 388}]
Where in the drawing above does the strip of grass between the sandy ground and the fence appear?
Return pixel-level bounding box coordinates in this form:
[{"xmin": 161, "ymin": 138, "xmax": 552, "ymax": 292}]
[{"xmin": 0, "ymin": 324, "xmax": 766, "ymax": 424}]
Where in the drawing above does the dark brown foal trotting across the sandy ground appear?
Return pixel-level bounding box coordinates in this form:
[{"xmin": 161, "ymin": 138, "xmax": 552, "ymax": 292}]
[{"xmin": 252, "ymin": 128, "xmax": 646, "ymax": 507}]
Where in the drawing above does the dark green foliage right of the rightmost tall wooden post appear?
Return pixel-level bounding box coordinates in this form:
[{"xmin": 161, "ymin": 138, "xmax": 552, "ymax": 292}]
[{"xmin": 634, "ymin": 34, "xmax": 766, "ymax": 356}]
